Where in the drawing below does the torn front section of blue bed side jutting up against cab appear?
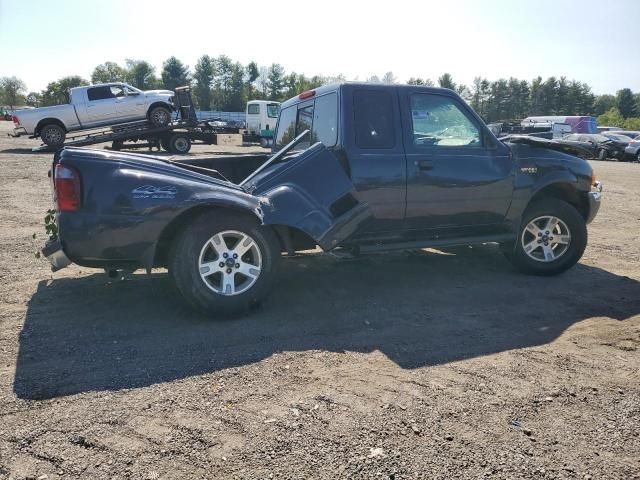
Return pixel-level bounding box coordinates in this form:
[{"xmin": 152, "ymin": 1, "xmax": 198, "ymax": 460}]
[{"xmin": 248, "ymin": 143, "xmax": 371, "ymax": 250}]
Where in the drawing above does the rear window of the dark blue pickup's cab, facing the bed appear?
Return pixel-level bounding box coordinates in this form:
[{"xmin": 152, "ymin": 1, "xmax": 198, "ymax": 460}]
[{"xmin": 274, "ymin": 91, "xmax": 338, "ymax": 150}]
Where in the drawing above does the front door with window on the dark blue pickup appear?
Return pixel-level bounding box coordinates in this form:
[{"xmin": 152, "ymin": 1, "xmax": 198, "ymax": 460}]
[{"xmin": 400, "ymin": 89, "xmax": 514, "ymax": 236}]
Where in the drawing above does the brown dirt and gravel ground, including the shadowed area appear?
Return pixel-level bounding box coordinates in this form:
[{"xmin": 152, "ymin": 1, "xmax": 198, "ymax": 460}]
[{"xmin": 0, "ymin": 122, "xmax": 640, "ymax": 479}]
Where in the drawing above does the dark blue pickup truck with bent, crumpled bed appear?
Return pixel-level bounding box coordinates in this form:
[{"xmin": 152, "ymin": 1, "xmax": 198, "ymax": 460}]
[{"xmin": 43, "ymin": 83, "xmax": 601, "ymax": 313}]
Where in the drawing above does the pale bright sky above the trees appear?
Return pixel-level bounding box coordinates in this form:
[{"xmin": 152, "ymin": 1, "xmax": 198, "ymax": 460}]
[{"xmin": 0, "ymin": 0, "xmax": 640, "ymax": 94}]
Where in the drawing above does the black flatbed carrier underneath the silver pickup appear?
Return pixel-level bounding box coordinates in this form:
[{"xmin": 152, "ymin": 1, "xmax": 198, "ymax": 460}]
[{"xmin": 27, "ymin": 87, "xmax": 238, "ymax": 154}]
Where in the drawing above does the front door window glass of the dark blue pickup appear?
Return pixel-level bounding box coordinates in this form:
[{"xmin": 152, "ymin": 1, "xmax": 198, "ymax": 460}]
[{"xmin": 411, "ymin": 93, "xmax": 482, "ymax": 147}]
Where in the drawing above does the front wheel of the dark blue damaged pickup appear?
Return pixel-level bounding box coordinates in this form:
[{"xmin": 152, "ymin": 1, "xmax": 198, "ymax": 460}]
[{"xmin": 501, "ymin": 199, "xmax": 587, "ymax": 275}]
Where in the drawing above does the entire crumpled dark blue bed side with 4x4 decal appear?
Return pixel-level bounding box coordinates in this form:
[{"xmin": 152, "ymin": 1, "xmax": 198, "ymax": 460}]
[{"xmin": 54, "ymin": 143, "xmax": 370, "ymax": 269}]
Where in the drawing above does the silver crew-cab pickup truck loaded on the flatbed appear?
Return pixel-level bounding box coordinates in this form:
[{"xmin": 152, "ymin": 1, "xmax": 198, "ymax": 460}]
[{"xmin": 12, "ymin": 83, "xmax": 175, "ymax": 146}]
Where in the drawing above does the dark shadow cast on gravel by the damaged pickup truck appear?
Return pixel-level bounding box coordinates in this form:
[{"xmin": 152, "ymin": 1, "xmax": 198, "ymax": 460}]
[{"xmin": 14, "ymin": 246, "xmax": 640, "ymax": 399}]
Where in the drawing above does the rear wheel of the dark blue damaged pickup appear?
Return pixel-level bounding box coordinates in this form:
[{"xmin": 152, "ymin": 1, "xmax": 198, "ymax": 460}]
[{"xmin": 168, "ymin": 210, "xmax": 280, "ymax": 316}]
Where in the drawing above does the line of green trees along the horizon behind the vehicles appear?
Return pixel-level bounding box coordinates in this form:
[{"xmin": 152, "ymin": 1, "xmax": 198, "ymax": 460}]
[{"xmin": 0, "ymin": 55, "xmax": 640, "ymax": 129}]
